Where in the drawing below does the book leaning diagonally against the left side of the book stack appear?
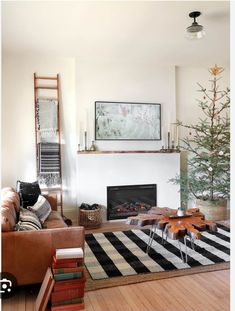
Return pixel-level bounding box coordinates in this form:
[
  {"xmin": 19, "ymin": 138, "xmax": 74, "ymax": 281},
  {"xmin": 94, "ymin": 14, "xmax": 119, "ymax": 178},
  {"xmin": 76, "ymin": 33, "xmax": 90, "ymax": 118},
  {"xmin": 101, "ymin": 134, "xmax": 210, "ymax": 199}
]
[{"xmin": 35, "ymin": 268, "xmax": 55, "ymax": 311}]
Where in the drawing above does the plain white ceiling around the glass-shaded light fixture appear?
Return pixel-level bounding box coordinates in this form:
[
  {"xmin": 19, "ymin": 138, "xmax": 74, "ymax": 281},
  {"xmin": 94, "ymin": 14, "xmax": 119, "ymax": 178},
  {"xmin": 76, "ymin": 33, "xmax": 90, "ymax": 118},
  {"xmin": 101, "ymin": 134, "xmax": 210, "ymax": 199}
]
[{"xmin": 2, "ymin": 1, "xmax": 230, "ymax": 66}]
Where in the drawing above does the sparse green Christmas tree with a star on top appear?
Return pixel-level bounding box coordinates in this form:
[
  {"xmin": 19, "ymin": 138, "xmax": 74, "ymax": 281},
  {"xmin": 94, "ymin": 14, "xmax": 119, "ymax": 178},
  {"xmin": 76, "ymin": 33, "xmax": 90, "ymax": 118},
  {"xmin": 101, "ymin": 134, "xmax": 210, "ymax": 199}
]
[{"xmin": 171, "ymin": 65, "xmax": 230, "ymax": 203}]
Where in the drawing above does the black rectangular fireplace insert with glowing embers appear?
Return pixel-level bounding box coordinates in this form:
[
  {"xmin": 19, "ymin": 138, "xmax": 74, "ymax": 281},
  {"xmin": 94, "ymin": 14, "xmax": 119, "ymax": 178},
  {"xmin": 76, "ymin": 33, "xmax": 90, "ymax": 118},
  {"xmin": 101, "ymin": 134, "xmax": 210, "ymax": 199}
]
[{"xmin": 107, "ymin": 184, "xmax": 157, "ymax": 220}]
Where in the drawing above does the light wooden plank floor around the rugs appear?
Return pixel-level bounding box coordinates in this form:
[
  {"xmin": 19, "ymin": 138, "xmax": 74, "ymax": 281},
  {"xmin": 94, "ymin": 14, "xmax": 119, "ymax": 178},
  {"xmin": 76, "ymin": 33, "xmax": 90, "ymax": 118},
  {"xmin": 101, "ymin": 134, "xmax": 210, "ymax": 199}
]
[{"xmin": 2, "ymin": 223, "xmax": 230, "ymax": 311}]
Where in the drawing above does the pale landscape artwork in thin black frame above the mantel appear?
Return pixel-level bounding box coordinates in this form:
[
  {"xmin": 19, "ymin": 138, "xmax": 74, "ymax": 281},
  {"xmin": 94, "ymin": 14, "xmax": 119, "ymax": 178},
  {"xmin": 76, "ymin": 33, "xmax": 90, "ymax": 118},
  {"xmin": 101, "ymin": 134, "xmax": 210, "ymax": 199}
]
[{"xmin": 95, "ymin": 101, "xmax": 161, "ymax": 140}]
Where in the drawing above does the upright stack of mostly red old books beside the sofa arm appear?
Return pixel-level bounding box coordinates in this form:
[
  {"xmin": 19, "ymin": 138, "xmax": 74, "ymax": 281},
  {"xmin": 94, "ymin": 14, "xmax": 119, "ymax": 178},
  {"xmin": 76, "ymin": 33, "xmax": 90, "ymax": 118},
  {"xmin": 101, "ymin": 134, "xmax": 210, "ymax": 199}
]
[{"xmin": 51, "ymin": 248, "xmax": 86, "ymax": 311}]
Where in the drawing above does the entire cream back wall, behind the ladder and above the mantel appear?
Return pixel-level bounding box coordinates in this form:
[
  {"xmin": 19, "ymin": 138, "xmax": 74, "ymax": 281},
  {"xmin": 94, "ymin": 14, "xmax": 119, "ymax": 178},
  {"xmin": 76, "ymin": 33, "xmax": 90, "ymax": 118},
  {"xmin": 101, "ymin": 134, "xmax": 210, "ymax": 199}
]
[{"xmin": 2, "ymin": 54, "xmax": 229, "ymax": 220}]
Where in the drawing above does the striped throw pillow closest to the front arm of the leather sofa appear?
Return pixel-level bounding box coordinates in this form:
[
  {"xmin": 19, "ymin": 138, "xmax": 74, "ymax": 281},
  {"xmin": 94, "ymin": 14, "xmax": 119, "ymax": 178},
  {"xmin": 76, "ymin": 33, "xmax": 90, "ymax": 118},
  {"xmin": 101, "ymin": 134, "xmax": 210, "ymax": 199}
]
[{"xmin": 15, "ymin": 208, "xmax": 42, "ymax": 231}]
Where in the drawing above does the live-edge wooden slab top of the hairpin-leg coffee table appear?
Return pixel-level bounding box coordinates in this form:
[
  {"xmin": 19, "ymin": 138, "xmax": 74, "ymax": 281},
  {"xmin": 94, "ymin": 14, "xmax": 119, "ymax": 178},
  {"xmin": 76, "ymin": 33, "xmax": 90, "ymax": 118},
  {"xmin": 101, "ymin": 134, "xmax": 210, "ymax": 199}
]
[{"xmin": 127, "ymin": 208, "xmax": 217, "ymax": 240}]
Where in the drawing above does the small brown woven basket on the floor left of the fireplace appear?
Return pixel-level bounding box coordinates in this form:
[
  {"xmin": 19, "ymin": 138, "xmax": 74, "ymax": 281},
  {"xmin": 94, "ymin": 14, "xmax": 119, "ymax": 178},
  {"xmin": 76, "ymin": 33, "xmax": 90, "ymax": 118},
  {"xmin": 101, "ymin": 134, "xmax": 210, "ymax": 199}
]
[{"xmin": 79, "ymin": 207, "xmax": 102, "ymax": 228}]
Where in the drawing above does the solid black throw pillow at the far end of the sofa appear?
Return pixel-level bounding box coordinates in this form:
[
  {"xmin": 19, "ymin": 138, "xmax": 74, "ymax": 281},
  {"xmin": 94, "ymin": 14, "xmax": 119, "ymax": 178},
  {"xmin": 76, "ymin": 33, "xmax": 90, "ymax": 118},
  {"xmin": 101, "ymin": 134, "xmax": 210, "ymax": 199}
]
[{"xmin": 16, "ymin": 180, "xmax": 41, "ymax": 208}]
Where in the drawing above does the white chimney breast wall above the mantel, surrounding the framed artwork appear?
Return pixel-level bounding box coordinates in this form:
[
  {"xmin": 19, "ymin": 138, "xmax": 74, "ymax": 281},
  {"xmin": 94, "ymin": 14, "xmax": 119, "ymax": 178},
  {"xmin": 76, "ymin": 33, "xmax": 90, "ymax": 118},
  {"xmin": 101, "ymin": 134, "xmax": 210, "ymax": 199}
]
[{"xmin": 76, "ymin": 61, "xmax": 176, "ymax": 150}]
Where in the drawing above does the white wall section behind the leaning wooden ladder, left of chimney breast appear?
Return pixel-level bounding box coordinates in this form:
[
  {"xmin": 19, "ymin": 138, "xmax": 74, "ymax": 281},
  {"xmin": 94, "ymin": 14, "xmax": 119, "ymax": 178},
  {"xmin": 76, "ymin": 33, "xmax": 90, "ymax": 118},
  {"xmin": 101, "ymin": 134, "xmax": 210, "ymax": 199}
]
[{"xmin": 2, "ymin": 55, "xmax": 76, "ymax": 223}]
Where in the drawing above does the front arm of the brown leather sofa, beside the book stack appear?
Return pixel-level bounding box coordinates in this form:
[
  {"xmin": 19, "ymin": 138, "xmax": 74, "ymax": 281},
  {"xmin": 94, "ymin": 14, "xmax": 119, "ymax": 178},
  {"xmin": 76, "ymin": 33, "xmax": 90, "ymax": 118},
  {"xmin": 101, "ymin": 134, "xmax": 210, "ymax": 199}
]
[{"xmin": 2, "ymin": 227, "xmax": 84, "ymax": 285}]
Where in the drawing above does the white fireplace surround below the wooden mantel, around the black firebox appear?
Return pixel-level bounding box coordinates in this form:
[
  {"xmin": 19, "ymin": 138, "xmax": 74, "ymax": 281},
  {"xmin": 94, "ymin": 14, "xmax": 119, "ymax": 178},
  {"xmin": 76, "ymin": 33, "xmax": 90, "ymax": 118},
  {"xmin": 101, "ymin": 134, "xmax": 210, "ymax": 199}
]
[{"xmin": 77, "ymin": 153, "xmax": 180, "ymax": 221}]
